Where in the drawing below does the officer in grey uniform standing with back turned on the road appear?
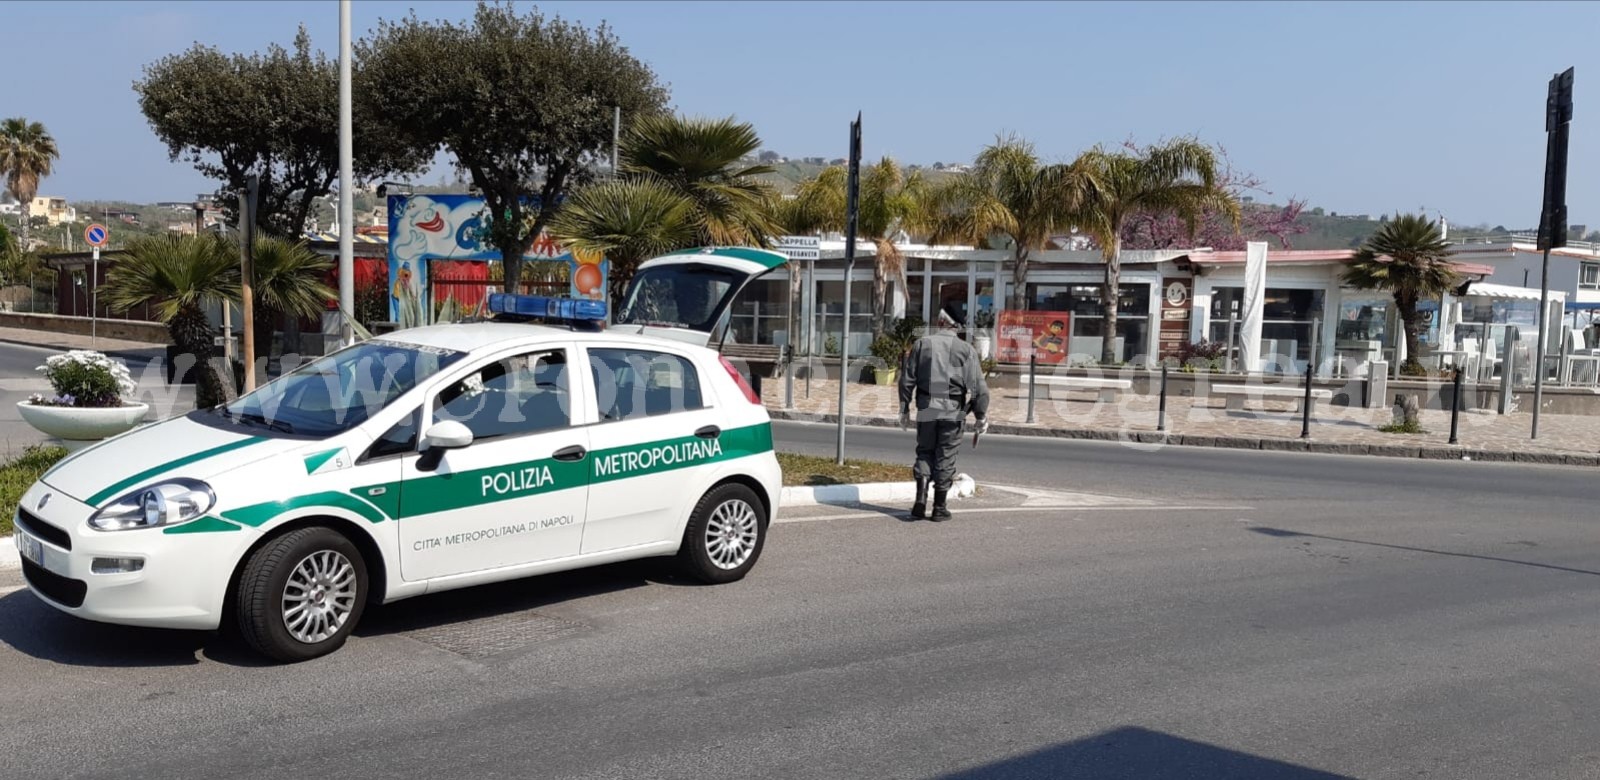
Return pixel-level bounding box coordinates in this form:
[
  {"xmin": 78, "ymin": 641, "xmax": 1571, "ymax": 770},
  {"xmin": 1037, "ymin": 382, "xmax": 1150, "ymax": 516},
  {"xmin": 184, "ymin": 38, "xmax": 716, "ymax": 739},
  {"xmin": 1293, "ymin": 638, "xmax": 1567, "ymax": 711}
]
[{"xmin": 899, "ymin": 318, "xmax": 989, "ymax": 523}]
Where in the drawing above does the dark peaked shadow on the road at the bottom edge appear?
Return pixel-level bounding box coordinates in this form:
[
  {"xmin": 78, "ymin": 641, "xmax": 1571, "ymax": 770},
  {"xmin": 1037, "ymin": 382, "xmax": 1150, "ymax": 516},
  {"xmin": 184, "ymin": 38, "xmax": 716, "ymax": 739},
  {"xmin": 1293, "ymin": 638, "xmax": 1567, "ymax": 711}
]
[{"xmin": 942, "ymin": 726, "xmax": 1346, "ymax": 780}]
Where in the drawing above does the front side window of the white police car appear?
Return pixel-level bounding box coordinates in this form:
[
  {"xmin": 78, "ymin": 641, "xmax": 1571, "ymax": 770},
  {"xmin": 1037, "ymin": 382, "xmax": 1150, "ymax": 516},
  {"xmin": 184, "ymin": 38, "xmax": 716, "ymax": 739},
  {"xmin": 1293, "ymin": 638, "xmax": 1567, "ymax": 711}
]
[{"xmin": 434, "ymin": 350, "xmax": 573, "ymax": 441}]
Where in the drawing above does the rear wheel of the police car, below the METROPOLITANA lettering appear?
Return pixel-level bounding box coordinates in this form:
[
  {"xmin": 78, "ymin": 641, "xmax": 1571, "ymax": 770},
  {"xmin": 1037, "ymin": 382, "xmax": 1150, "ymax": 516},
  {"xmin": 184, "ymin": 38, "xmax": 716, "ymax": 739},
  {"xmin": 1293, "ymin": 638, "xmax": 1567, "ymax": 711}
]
[{"xmin": 678, "ymin": 483, "xmax": 766, "ymax": 583}]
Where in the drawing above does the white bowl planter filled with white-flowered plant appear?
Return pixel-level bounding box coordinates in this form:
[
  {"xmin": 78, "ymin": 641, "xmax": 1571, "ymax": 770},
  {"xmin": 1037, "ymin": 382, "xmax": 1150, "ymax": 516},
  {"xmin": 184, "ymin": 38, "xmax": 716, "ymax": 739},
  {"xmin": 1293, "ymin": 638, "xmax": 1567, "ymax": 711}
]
[{"xmin": 16, "ymin": 350, "xmax": 150, "ymax": 446}]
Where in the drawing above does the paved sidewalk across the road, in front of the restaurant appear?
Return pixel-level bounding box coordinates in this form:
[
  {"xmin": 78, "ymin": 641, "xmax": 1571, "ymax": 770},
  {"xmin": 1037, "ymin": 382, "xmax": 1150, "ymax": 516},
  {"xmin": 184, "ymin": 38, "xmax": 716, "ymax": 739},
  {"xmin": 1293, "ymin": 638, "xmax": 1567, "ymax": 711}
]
[{"xmin": 762, "ymin": 379, "xmax": 1600, "ymax": 467}]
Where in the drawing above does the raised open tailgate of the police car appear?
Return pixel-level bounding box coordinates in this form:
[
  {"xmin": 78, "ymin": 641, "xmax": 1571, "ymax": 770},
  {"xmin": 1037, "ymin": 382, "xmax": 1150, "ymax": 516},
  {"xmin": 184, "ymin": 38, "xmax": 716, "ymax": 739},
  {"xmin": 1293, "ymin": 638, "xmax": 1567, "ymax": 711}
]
[{"xmin": 611, "ymin": 246, "xmax": 789, "ymax": 348}]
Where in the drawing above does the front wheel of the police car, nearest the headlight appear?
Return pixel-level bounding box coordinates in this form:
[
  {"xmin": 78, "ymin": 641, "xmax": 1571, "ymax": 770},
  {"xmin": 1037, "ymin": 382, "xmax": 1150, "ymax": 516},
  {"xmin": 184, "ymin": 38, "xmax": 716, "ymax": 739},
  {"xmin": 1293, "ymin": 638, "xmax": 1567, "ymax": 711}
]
[{"xmin": 235, "ymin": 526, "xmax": 366, "ymax": 662}]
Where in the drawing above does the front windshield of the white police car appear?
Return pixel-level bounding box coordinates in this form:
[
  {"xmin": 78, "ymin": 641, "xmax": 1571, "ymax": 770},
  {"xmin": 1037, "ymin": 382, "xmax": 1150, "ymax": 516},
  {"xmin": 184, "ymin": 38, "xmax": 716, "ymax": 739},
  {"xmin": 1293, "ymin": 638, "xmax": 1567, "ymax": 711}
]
[{"xmin": 214, "ymin": 339, "xmax": 464, "ymax": 436}]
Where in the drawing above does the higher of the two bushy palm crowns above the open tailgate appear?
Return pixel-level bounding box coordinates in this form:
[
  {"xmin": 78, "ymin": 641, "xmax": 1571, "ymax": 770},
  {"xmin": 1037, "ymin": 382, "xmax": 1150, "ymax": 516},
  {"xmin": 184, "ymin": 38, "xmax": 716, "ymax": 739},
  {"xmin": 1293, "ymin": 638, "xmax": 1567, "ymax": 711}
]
[{"xmin": 613, "ymin": 115, "xmax": 779, "ymax": 246}]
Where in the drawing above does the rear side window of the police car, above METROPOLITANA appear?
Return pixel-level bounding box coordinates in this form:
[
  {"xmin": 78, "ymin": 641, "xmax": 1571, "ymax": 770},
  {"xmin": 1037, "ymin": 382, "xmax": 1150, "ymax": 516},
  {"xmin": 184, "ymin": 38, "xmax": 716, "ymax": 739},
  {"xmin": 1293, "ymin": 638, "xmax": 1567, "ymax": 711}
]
[{"xmin": 589, "ymin": 348, "xmax": 706, "ymax": 422}]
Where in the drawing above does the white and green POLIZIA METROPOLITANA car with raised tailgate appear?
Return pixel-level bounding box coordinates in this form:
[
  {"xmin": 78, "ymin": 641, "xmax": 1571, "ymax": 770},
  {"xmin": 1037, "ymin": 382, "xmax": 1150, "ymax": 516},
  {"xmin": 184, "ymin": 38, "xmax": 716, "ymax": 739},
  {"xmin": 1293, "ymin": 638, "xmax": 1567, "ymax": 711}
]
[{"xmin": 16, "ymin": 249, "xmax": 784, "ymax": 660}]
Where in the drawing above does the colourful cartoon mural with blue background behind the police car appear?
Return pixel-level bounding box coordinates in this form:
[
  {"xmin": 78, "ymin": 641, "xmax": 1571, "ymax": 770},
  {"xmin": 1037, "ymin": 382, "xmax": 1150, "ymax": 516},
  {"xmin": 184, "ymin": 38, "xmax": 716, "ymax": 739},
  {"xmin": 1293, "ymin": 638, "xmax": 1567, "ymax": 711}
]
[{"xmin": 389, "ymin": 195, "xmax": 610, "ymax": 328}]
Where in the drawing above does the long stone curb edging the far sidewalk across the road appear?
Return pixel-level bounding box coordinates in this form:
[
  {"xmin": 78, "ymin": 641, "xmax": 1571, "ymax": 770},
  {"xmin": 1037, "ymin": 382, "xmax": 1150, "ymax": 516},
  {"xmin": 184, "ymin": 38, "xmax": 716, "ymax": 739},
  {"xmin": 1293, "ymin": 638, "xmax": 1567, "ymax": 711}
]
[{"xmin": 768, "ymin": 409, "xmax": 1600, "ymax": 467}]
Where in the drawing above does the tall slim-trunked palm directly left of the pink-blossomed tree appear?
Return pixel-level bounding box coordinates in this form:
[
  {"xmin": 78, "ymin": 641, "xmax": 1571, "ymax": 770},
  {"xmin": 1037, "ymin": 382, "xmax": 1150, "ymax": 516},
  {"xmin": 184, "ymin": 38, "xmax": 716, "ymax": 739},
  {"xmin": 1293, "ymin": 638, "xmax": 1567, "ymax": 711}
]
[{"xmin": 1072, "ymin": 137, "xmax": 1240, "ymax": 363}]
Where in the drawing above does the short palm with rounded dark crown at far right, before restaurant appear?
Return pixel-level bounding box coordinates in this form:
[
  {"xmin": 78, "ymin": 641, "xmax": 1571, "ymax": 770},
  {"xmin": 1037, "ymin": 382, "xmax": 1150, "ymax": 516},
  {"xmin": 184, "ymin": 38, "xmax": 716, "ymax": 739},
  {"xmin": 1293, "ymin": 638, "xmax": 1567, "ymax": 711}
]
[{"xmin": 1344, "ymin": 214, "xmax": 1461, "ymax": 376}]
